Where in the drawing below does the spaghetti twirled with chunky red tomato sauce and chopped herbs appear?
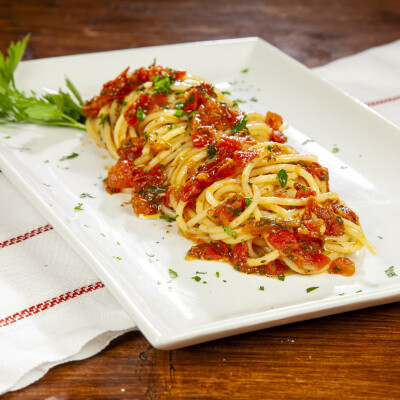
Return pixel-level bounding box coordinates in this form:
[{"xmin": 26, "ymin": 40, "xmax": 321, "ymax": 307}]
[{"xmin": 83, "ymin": 65, "xmax": 376, "ymax": 276}]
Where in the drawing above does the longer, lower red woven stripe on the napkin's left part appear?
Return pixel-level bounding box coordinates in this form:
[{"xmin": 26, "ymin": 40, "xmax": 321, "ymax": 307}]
[{"xmin": 0, "ymin": 282, "xmax": 104, "ymax": 328}]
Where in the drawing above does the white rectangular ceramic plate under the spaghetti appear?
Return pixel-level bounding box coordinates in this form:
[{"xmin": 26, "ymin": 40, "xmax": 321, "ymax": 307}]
[{"xmin": 0, "ymin": 38, "xmax": 400, "ymax": 349}]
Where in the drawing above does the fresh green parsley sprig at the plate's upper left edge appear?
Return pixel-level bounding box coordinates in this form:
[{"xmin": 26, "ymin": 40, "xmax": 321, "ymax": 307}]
[{"xmin": 0, "ymin": 35, "xmax": 85, "ymax": 129}]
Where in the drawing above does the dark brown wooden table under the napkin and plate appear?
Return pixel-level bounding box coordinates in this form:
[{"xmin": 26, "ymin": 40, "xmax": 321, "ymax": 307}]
[{"xmin": 0, "ymin": 0, "xmax": 400, "ymax": 400}]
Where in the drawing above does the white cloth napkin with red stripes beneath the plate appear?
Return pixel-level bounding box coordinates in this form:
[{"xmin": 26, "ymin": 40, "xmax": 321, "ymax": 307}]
[{"xmin": 0, "ymin": 40, "xmax": 400, "ymax": 394}]
